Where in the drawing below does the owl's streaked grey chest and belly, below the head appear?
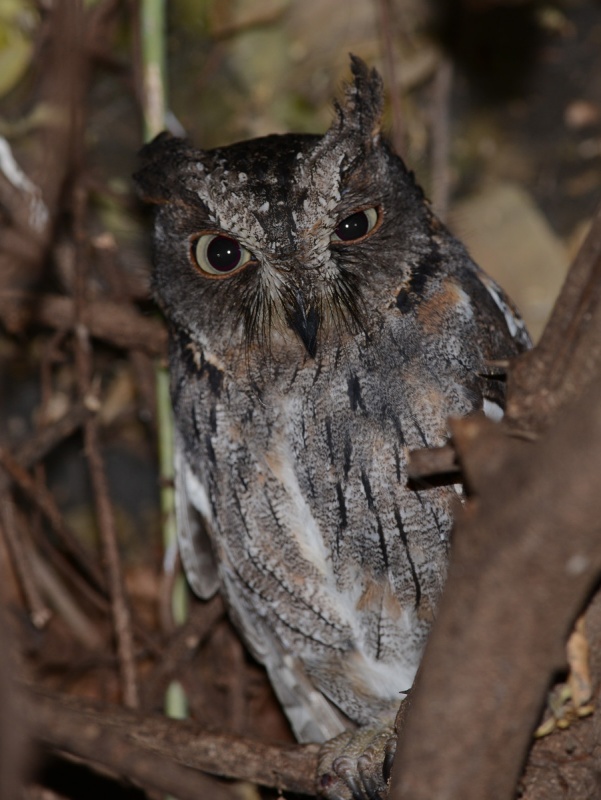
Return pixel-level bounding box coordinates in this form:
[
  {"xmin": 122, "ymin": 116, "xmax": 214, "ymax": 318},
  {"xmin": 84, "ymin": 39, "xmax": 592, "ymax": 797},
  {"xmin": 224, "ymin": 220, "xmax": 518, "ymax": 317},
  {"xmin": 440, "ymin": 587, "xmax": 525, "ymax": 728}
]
[{"xmin": 173, "ymin": 328, "xmax": 470, "ymax": 680}]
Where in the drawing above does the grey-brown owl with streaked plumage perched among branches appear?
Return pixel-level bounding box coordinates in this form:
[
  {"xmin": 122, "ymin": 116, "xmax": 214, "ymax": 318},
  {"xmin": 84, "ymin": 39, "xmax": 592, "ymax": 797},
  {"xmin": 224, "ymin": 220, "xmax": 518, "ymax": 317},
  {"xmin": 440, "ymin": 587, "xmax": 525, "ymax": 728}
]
[{"xmin": 136, "ymin": 58, "xmax": 529, "ymax": 756}]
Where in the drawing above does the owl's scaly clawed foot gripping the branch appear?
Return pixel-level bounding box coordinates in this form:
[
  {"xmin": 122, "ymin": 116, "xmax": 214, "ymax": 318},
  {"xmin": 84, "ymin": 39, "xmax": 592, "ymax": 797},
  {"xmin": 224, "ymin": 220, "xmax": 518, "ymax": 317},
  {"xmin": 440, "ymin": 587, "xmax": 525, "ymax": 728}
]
[{"xmin": 317, "ymin": 724, "xmax": 396, "ymax": 800}]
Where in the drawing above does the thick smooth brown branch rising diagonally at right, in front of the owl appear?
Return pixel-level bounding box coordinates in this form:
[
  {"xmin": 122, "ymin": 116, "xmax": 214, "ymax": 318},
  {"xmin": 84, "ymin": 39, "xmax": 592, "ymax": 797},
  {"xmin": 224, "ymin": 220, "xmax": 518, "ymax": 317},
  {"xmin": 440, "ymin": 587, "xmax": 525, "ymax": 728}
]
[{"xmin": 391, "ymin": 379, "xmax": 601, "ymax": 800}]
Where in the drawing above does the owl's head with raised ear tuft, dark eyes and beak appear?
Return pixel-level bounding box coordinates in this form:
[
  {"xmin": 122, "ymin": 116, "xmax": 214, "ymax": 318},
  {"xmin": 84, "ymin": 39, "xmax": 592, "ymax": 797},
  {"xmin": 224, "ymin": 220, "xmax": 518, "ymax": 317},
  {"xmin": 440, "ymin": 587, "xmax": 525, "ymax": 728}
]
[{"xmin": 135, "ymin": 57, "xmax": 430, "ymax": 358}]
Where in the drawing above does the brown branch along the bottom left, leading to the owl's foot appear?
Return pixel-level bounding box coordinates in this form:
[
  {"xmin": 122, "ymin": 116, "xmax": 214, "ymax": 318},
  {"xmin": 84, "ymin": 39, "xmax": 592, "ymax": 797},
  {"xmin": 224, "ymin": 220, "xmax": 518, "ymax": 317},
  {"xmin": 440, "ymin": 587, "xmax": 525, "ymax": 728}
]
[{"xmin": 26, "ymin": 690, "xmax": 319, "ymax": 800}]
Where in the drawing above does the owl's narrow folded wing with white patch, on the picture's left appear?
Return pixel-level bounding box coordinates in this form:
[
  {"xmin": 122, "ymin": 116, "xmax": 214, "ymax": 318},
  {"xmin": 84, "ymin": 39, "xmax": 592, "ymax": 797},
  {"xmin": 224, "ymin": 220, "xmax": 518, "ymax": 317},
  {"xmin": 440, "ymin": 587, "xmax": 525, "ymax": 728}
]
[{"xmin": 175, "ymin": 433, "xmax": 219, "ymax": 600}]
